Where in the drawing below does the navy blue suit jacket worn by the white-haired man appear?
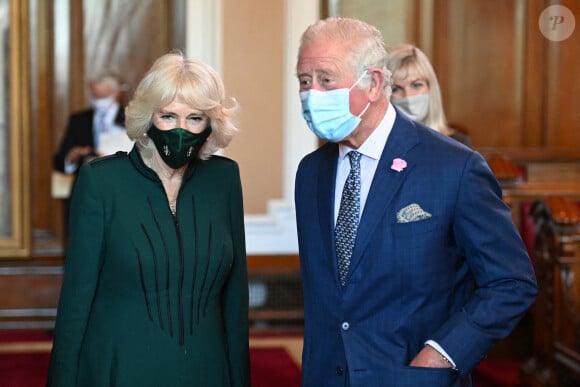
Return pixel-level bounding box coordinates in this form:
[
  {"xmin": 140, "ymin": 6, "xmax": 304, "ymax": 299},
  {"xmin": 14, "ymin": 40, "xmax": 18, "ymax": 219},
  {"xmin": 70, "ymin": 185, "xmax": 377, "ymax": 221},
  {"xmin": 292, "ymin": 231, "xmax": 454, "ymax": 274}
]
[{"xmin": 295, "ymin": 113, "xmax": 537, "ymax": 387}]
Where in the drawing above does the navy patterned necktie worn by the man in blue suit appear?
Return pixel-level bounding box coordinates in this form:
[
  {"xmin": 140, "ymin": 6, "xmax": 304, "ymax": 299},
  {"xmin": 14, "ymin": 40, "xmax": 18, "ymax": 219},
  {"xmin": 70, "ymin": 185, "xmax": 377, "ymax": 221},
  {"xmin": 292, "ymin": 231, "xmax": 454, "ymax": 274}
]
[{"xmin": 334, "ymin": 151, "xmax": 361, "ymax": 286}]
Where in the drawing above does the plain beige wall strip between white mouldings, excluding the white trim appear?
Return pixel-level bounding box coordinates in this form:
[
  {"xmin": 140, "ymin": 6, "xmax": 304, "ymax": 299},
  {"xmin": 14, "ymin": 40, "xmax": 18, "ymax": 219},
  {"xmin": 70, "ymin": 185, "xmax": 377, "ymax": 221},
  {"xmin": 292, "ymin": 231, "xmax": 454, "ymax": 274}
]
[{"xmin": 222, "ymin": 0, "xmax": 284, "ymax": 214}]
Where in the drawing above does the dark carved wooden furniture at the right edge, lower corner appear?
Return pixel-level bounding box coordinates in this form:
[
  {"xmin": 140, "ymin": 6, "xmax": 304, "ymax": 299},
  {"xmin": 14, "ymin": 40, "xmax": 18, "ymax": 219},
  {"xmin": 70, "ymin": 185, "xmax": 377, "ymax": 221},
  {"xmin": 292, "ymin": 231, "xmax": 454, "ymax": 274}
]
[{"xmin": 521, "ymin": 196, "xmax": 580, "ymax": 387}]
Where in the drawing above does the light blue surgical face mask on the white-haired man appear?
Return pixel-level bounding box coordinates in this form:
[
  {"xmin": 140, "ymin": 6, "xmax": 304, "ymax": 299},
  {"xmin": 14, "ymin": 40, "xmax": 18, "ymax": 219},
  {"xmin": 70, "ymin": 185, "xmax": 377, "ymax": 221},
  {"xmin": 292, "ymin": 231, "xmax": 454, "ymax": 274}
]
[{"xmin": 300, "ymin": 71, "xmax": 370, "ymax": 142}]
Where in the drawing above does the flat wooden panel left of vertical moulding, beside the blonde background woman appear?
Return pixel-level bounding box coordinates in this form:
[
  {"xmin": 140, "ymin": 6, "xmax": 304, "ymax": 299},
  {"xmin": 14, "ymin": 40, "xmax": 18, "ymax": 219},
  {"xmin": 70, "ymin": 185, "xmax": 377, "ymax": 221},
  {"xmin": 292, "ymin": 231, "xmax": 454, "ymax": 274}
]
[{"xmin": 434, "ymin": 0, "xmax": 523, "ymax": 147}]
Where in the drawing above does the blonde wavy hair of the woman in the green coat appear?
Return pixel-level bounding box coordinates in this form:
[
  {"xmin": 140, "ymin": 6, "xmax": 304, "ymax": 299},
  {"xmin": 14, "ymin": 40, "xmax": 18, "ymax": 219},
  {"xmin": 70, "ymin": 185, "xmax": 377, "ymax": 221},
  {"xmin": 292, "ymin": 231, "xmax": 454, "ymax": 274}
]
[{"xmin": 125, "ymin": 51, "xmax": 239, "ymax": 160}]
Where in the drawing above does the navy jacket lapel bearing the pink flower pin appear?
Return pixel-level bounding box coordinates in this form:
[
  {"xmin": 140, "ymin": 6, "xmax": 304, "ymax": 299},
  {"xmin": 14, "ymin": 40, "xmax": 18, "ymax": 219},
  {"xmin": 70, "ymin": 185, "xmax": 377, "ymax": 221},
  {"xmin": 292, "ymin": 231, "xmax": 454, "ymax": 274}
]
[{"xmin": 349, "ymin": 114, "xmax": 419, "ymax": 273}]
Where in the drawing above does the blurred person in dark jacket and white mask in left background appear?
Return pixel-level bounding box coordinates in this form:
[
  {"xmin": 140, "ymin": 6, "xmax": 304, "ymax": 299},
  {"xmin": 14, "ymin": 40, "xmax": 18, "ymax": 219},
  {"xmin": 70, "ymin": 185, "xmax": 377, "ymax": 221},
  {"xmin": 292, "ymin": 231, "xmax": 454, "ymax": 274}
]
[{"xmin": 53, "ymin": 75, "xmax": 130, "ymax": 174}]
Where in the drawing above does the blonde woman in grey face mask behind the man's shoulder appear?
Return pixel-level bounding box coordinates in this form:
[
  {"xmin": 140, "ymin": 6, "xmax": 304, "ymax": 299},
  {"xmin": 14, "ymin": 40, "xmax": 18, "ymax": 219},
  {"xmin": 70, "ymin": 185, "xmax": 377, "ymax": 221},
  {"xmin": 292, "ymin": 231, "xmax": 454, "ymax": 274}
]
[{"xmin": 388, "ymin": 44, "xmax": 471, "ymax": 146}]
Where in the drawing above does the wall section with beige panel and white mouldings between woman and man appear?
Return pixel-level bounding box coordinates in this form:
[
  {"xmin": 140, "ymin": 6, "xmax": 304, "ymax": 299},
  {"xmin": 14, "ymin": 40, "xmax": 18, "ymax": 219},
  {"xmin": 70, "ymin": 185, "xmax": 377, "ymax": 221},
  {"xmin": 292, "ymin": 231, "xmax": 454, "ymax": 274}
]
[{"xmin": 186, "ymin": 0, "xmax": 319, "ymax": 255}]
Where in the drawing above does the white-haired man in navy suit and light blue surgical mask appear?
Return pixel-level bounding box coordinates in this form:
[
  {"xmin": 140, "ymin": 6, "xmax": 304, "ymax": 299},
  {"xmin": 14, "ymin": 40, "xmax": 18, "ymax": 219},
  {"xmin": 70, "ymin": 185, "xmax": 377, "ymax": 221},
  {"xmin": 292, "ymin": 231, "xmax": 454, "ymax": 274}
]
[{"xmin": 295, "ymin": 18, "xmax": 538, "ymax": 387}]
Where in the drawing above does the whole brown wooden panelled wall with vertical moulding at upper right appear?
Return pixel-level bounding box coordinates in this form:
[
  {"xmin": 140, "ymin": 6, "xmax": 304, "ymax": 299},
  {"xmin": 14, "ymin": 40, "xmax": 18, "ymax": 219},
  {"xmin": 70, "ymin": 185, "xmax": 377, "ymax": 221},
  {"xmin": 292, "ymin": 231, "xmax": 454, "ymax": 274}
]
[{"xmin": 433, "ymin": 0, "xmax": 580, "ymax": 150}]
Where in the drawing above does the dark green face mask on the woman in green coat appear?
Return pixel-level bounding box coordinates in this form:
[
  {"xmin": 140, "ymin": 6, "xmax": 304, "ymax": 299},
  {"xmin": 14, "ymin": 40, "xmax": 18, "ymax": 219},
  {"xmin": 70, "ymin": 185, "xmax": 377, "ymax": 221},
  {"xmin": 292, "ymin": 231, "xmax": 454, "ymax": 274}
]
[{"xmin": 147, "ymin": 124, "xmax": 211, "ymax": 169}]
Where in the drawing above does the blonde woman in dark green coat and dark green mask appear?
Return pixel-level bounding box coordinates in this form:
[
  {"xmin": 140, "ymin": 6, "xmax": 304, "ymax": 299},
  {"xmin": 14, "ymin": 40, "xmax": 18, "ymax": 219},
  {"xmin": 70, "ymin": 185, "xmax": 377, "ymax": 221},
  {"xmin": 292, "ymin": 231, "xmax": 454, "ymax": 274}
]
[{"xmin": 47, "ymin": 53, "xmax": 250, "ymax": 387}]
